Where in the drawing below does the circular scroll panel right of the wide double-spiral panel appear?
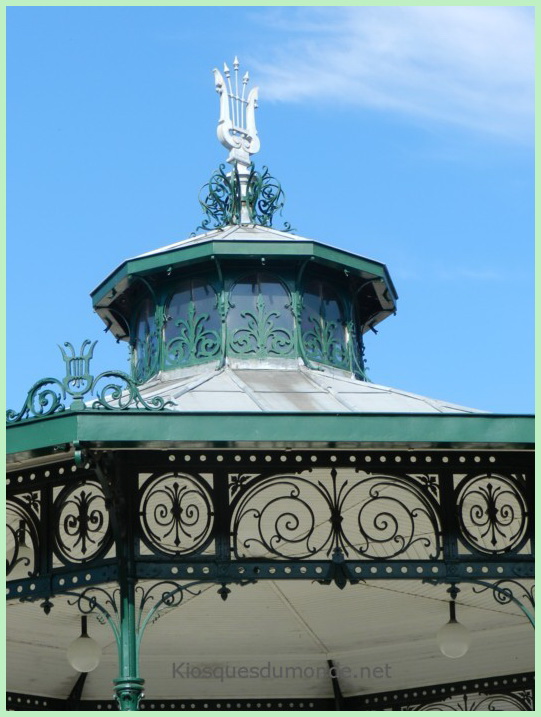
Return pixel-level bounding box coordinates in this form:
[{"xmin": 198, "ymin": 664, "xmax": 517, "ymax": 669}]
[{"xmin": 457, "ymin": 474, "xmax": 529, "ymax": 554}]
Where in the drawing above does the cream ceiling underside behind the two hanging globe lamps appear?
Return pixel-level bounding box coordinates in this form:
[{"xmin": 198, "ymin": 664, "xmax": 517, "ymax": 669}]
[{"xmin": 7, "ymin": 580, "xmax": 534, "ymax": 699}]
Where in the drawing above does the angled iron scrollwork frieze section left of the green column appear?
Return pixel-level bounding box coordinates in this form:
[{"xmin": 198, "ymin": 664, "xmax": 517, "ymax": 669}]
[{"xmin": 6, "ymin": 460, "xmax": 117, "ymax": 599}]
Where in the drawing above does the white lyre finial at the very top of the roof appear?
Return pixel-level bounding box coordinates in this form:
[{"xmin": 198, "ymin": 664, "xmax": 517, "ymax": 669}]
[{"xmin": 214, "ymin": 57, "xmax": 260, "ymax": 174}]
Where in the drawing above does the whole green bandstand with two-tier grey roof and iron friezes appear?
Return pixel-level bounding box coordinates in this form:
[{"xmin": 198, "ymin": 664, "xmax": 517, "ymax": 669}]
[{"xmin": 6, "ymin": 60, "xmax": 534, "ymax": 711}]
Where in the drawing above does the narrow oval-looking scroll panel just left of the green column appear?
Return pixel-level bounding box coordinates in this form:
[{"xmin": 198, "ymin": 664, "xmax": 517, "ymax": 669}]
[{"xmin": 54, "ymin": 480, "xmax": 112, "ymax": 564}]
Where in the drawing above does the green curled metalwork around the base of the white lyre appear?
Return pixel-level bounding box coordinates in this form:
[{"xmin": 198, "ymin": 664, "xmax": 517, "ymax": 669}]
[{"xmin": 192, "ymin": 164, "xmax": 293, "ymax": 236}]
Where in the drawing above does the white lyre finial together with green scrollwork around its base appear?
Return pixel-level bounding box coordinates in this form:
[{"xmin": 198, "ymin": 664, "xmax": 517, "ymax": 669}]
[{"xmin": 197, "ymin": 57, "xmax": 291, "ymax": 231}]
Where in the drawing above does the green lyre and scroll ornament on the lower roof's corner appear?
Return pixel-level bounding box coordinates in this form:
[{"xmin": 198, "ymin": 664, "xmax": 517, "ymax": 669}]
[{"xmin": 6, "ymin": 339, "xmax": 172, "ymax": 424}]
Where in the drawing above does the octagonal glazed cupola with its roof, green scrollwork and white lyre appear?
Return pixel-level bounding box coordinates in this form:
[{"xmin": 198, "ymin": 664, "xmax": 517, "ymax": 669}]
[{"xmin": 92, "ymin": 58, "xmax": 397, "ymax": 384}]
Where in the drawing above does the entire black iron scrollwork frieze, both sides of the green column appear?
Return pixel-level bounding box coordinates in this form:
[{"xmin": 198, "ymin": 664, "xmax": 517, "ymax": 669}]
[{"xmin": 7, "ymin": 447, "xmax": 533, "ymax": 599}]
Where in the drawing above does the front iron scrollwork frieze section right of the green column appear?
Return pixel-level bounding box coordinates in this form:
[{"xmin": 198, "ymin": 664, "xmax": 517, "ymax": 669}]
[{"xmin": 125, "ymin": 449, "xmax": 533, "ymax": 577}]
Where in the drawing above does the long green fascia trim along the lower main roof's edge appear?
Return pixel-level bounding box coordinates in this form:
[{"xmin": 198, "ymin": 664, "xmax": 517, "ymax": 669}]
[{"xmin": 6, "ymin": 410, "xmax": 534, "ymax": 456}]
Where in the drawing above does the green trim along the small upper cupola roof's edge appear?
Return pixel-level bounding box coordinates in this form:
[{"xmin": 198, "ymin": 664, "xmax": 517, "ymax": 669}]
[{"xmin": 90, "ymin": 239, "xmax": 398, "ymax": 306}]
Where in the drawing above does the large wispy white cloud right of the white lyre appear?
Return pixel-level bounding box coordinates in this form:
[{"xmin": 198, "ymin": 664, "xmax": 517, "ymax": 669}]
[{"xmin": 251, "ymin": 6, "xmax": 534, "ymax": 140}]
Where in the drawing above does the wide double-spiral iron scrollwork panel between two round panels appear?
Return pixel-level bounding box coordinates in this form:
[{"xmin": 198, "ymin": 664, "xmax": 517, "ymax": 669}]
[{"xmin": 232, "ymin": 468, "xmax": 442, "ymax": 560}]
